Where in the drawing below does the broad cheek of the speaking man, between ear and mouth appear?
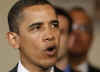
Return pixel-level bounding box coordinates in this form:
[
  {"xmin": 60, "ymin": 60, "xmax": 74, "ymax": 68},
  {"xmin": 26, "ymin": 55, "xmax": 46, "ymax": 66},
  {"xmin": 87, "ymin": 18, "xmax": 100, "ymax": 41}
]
[{"xmin": 20, "ymin": 36, "xmax": 41, "ymax": 58}]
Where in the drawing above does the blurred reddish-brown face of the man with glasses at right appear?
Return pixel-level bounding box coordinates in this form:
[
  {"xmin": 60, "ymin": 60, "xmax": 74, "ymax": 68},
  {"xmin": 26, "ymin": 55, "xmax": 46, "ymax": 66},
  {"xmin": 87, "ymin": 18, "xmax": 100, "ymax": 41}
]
[{"xmin": 68, "ymin": 11, "xmax": 92, "ymax": 56}]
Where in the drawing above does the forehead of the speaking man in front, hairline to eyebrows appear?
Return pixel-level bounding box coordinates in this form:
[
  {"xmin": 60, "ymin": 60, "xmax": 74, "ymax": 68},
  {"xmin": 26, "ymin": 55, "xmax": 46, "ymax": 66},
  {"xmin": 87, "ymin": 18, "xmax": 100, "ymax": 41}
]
[{"xmin": 18, "ymin": 4, "xmax": 56, "ymax": 23}]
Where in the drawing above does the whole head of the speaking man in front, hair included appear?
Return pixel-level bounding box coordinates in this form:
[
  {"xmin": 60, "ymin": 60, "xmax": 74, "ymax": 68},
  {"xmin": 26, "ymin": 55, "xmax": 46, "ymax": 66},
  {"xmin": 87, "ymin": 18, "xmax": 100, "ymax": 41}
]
[{"xmin": 7, "ymin": 0, "xmax": 59, "ymax": 68}]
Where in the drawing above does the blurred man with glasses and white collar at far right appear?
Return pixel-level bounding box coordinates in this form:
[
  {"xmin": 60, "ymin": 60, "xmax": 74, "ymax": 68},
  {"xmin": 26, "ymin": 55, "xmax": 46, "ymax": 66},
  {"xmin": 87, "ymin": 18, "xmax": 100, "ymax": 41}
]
[{"xmin": 67, "ymin": 8, "xmax": 100, "ymax": 72}]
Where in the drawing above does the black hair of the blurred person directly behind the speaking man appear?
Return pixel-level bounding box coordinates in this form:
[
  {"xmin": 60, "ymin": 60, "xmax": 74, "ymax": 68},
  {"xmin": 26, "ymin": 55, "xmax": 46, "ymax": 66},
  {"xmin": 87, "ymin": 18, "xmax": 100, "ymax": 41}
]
[{"xmin": 55, "ymin": 6, "xmax": 72, "ymax": 33}]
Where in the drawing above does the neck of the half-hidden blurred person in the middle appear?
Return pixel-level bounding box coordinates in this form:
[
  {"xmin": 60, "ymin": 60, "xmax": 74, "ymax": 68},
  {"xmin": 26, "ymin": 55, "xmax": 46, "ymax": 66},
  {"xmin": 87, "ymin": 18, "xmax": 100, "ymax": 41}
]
[{"xmin": 56, "ymin": 57, "xmax": 68, "ymax": 71}]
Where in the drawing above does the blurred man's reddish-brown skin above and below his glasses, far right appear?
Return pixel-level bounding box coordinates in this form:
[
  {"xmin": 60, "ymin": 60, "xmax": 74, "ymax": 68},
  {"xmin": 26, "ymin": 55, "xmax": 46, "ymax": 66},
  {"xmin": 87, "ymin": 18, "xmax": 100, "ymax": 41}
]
[{"xmin": 68, "ymin": 11, "xmax": 93, "ymax": 67}]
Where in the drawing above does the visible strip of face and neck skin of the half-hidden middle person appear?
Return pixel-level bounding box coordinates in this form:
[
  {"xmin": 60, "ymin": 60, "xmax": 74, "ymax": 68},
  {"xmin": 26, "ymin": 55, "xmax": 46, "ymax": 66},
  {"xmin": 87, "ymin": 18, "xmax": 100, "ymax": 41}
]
[{"xmin": 56, "ymin": 15, "xmax": 69, "ymax": 70}]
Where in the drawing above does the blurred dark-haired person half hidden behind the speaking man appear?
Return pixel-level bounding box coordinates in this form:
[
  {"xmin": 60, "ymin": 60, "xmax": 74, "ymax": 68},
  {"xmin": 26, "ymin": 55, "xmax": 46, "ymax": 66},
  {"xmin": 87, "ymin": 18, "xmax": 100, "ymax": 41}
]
[{"xmin": 55, "ymin": 7, "xmax": 72, "ymax": 72}]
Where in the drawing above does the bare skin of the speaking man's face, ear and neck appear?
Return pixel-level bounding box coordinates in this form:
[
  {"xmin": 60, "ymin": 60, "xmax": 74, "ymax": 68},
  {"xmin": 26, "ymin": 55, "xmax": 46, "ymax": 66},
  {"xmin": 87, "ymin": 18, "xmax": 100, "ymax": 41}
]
[{"xmin": 7, "ymin": 4, "xmax": 59, "ymax": 72}]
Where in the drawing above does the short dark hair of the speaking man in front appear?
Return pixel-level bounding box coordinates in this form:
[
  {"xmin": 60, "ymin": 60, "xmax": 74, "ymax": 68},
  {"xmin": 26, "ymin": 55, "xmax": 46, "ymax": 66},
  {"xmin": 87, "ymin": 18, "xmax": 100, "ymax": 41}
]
[{"xmin": 8, "ymin": 0, "xmax": 53, "ymax": 33}]
